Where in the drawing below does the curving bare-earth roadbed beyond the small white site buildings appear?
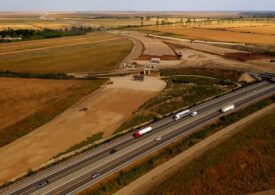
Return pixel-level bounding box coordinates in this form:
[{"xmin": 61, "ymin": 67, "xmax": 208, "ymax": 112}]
[{"xmin": 117, "ymin": 32, "xmax": 177, "ymax": 59}]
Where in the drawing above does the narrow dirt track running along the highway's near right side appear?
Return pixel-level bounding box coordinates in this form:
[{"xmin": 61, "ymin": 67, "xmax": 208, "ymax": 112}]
[{"xmin": 114, "ymin": 104, "xmax": 275, "ymax": 195}]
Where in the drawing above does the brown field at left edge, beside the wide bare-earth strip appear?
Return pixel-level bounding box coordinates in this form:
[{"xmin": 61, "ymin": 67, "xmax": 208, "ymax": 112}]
[{"xmin": 0, "ymin": 78, "xmax": 104, "ymax": 147}]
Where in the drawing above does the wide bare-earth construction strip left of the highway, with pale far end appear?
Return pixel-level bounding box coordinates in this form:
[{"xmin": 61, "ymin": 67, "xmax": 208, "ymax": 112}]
[{"xmin": 0, "ymin": 77, "xmax": 165, "ymax": 182}]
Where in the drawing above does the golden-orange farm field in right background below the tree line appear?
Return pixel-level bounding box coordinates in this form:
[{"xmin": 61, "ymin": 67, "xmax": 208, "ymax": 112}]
[{"xmin": 143, "ymin": 26, "xmax": 275, "ymax": 46}]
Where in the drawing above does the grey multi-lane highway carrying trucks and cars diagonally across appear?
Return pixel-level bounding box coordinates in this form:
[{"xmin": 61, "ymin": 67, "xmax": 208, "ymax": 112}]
[{"xmin": 0, "ymin": 81, "xmax": 275, "ymax": 194}]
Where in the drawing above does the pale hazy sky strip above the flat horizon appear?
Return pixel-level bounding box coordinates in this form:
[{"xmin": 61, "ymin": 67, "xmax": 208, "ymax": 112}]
[{"xmin": 0, "ymin": 0, "xmax": 275, "ymax": 11}]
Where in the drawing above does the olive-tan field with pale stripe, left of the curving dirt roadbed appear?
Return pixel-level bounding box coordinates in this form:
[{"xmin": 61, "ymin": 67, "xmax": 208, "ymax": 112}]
[{"xmin": 0, "ymin": 32, "xmax": 133, "ymax": 73}]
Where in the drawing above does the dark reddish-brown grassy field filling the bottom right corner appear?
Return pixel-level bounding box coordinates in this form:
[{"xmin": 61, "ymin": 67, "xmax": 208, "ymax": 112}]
[{"xmin": 147, "ymin": 106, "xmax": 275, "ymax": 195}]
